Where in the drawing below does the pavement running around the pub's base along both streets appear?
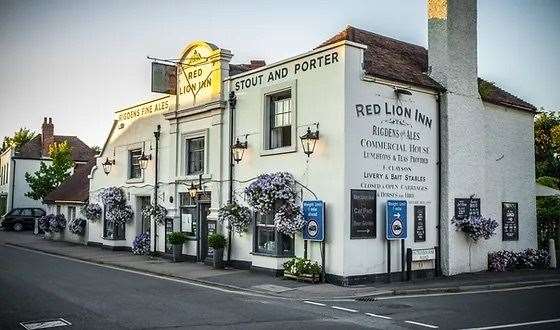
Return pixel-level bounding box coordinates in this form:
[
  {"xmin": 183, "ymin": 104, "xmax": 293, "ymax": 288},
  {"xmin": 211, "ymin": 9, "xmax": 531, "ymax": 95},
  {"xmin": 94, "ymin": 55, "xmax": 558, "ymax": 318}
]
[{"xmin": 0, "ymin": 231, "xmax": 560, "ymax": 301}]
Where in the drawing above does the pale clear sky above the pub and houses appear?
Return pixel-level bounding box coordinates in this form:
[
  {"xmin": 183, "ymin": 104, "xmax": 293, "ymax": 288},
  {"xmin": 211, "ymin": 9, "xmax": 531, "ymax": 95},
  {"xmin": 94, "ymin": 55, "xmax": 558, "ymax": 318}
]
[{"xmin": 0, "ymin": 0, "xmax": 560, "ymax": 145}]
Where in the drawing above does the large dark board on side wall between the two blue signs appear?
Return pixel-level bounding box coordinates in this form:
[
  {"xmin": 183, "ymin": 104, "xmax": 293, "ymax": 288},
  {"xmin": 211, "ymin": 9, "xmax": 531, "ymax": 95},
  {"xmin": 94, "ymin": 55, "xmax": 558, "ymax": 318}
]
[{"xmin": 350, "ymin": 189, "xmax": 377, "ymax": 239}]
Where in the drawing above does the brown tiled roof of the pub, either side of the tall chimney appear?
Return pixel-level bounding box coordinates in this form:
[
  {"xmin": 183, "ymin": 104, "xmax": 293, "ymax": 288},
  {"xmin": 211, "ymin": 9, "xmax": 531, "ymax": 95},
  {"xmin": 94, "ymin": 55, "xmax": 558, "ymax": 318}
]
[{"xmin": 318, "ymin": 26, "xmax": 537, "ymax": 112}]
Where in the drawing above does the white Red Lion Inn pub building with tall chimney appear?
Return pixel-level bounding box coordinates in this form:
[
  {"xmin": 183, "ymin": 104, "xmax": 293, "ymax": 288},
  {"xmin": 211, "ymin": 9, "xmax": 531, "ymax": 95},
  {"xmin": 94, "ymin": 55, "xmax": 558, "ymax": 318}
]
[{"xmin": 87, "ymin": 0, "xmax": 537, "ymax": 285}]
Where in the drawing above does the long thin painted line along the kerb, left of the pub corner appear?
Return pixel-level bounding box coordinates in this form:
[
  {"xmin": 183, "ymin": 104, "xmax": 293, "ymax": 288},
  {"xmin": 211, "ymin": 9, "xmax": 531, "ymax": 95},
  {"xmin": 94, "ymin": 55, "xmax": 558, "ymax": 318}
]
[{"xmin": 4, "ymin": 245, "xmax": 270, "ymax": 299}]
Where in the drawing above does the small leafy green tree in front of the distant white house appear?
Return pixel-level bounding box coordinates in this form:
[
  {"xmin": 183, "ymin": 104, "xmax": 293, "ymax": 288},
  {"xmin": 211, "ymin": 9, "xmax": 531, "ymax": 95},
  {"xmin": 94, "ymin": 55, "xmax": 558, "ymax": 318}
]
[{"xmin": 25, "ymin": 141, "xmax": 74, "ymax": 200}]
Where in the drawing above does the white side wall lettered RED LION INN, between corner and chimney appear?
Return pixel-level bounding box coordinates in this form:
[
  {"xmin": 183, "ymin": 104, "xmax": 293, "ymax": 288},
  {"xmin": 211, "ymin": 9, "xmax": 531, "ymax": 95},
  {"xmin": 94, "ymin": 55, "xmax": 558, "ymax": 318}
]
[{"xmin": 341, "ymin": 47, "xmax": 439, "ymax": 276}]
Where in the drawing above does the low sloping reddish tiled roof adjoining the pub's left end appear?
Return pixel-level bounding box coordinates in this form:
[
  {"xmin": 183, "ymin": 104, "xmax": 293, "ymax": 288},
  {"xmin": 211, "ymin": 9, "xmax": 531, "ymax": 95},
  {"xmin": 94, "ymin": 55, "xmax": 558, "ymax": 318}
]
[{"xmin": 43, "ymin": 159, "xmax": 95, "ymax": 204}]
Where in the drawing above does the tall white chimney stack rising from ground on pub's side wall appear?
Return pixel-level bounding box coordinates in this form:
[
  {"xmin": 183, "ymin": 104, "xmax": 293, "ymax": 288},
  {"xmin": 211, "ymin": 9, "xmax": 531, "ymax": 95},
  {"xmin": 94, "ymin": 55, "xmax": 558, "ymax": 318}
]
[{"xmin": 428, "ymin": 0, "xmax": 493, "ymax": 275}]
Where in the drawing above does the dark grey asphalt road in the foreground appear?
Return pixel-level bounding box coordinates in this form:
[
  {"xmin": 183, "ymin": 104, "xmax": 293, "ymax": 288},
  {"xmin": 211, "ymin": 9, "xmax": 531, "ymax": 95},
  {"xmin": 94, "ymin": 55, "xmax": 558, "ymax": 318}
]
[{"xmin": 0, "ymin": 245, "xmax": 560, "ymax": 329}]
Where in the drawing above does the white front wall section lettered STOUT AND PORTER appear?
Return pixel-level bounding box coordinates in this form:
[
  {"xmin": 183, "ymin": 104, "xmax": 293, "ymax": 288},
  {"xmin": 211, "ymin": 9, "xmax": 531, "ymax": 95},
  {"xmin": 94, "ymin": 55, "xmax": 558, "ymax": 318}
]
[{"xmin": 222, "ymin": 45, "xmax": 347, "ymax": 274}]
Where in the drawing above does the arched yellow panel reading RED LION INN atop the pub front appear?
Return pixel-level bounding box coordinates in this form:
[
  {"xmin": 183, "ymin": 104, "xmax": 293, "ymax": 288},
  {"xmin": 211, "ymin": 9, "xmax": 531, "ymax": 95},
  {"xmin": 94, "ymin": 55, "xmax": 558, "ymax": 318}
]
[{"xmin": 177, "ymin": 41, "xmax": 222, "ymax": 110}]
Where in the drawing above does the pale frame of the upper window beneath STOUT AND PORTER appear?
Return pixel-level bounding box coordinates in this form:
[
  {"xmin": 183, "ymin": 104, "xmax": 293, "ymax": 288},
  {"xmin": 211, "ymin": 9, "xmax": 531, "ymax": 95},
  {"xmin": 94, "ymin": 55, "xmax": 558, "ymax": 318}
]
[{"xmin": 260, "ymin": 80, "xmax": 298, "ymax": 156}]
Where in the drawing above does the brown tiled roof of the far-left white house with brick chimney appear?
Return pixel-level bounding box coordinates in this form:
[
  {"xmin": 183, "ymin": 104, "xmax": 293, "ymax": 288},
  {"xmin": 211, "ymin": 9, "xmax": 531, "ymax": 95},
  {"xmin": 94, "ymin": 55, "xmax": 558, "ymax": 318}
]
[{"xmin": 16, "ymin": 134, "xmax": 95, "ymax": 162}]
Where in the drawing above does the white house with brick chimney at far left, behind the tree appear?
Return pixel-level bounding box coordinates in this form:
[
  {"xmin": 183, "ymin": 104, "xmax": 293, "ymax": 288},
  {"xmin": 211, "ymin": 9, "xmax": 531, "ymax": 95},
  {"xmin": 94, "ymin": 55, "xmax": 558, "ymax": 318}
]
[{"xmin": 0, "ymin": 117, "xmax": 95, "ymax": 214}]
